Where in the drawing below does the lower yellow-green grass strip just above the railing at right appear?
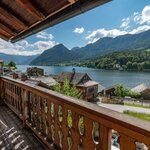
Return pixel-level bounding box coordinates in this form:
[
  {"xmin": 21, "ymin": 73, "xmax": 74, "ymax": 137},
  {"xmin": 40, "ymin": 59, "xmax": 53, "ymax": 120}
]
[{"xmin": 123, "ymin": 110, "xmax": 150, "ymax": 121}]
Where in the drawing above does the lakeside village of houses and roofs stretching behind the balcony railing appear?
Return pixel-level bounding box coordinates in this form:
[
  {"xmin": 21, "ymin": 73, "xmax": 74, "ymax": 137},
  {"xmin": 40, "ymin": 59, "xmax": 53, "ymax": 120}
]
[{"xmin": 0, "ymin": 60, "xmax": 150, "ymax": 106}]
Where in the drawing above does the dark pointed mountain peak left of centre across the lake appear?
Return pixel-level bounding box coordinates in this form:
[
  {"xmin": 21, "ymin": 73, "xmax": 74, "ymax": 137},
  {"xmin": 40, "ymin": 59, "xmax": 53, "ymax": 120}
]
[{"xmin": 31, "ymin": 44, "xmax": 78, "ymax": 65}]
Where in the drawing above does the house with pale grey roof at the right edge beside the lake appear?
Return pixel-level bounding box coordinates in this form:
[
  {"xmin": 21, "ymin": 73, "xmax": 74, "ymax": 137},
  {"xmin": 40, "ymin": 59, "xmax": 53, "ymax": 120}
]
[{"xmin": 131, "ymin": 83, "xmax": 150, "ymax": 100}]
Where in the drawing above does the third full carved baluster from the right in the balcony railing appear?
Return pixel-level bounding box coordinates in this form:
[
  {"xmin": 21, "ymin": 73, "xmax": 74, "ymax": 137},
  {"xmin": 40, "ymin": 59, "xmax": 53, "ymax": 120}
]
[{"xmin": 83, "ymin": 117, "xmax": 95, "ymax": 150}]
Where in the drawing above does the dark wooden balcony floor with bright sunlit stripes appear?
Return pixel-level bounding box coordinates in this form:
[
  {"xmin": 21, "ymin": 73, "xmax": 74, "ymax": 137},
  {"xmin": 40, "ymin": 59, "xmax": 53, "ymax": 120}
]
[{"xmin": 0, "ymin": 106, "xmax": 45, "ymax": 150}]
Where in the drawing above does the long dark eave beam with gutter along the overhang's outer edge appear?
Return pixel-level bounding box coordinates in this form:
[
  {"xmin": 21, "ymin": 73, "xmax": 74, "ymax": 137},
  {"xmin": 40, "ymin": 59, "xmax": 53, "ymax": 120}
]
[{"xmin": 11, "ymin": 0, "xmax": 111, "ymax": 42}]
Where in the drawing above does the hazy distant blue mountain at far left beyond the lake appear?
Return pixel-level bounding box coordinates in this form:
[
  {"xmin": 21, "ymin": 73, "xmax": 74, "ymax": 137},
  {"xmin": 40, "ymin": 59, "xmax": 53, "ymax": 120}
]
[{"xmin": 0, "ymin": 53, "xmax": 38, "ymax": 65}]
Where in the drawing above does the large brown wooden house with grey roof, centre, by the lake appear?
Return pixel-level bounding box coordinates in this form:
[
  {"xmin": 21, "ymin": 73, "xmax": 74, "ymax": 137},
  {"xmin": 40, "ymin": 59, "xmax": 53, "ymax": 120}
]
[{"xmin": 57, "ymin": 71, "xmax": 98, "ymax": 101}]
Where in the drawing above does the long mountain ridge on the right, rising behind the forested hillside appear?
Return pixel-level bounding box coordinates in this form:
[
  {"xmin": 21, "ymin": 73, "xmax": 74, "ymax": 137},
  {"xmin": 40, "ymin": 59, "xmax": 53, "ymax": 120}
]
[{"xmin": 76, "ymin": 30, "xmax": 150, "ymax": 59}]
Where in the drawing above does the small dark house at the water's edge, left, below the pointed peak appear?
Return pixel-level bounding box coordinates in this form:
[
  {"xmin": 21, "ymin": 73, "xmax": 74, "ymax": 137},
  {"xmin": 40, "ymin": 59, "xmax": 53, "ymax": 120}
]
[{"xmin": 27, "ymin": 67, "xmax": 44, "ymax": 76}]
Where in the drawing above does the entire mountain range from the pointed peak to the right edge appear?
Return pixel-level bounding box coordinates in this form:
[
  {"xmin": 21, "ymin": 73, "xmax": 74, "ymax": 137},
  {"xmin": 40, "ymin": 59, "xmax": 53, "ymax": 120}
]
[{"xmin": 31, "ymin": 30, "xmax": 150, "ymax": 65}]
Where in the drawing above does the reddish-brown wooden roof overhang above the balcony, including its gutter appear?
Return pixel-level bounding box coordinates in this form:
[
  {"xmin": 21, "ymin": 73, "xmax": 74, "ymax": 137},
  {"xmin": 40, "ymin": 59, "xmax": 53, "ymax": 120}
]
[{"xmin": 0, "ymin": 0, "xmax": 111, "ymax": 42}]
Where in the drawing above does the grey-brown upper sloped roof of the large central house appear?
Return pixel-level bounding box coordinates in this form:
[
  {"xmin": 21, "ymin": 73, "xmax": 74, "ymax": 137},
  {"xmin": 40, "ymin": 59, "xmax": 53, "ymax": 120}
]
[{"xmin": 57, "ymin": 72, "xmax": 90, "ymax": 85}]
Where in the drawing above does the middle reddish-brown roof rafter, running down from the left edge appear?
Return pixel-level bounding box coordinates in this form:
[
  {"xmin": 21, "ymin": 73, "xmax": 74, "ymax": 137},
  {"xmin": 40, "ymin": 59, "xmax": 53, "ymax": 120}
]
[{"xmin": 0, "ymin": 6, "xmax": 28, "ymax": 29}]
